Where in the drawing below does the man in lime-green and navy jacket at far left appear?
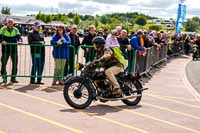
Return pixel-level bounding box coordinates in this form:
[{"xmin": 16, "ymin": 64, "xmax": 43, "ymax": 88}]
[{"xmin": 0, "ymin": 19, "xmax": 22, "ymax": 83}]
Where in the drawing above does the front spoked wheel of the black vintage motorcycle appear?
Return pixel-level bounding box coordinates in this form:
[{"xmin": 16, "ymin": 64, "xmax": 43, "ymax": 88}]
[{"xmin": 63, "ymin": 78, "xmax": 92, "ymax": 109}]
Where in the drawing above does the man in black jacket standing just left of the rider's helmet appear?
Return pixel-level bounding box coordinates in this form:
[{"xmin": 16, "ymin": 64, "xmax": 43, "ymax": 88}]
[{"xmin": 82, "ymin": 25, "xmax": 96, "ymax": 63}]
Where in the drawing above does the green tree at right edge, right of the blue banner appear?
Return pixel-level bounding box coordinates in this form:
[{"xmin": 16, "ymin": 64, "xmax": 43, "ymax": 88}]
[{"xmin": 185, "ymin": 19, "xmax": 199, "ymax": 32}]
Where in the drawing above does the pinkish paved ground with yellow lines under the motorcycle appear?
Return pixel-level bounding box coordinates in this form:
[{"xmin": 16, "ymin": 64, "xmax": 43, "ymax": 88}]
[{"xmin": 0, "ymin": 57, "xmax": 200, "ymax": 133}]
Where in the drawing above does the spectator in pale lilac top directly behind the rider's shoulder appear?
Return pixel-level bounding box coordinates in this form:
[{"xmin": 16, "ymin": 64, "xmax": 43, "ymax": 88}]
[{"xmin": 105, "ymin": 30, "xmax": 120, "ymax": 48}]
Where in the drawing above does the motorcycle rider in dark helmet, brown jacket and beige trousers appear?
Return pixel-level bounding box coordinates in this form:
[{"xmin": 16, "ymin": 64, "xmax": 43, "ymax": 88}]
[{"xmin": 92, "ymin": 36, "xmax": 123, "ymax": 97}]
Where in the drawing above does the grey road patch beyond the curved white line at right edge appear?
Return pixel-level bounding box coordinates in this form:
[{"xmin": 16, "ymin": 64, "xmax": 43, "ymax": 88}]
[{"xmin": 186, "ymin": 60, "xmax": 200, "ymax": 93}]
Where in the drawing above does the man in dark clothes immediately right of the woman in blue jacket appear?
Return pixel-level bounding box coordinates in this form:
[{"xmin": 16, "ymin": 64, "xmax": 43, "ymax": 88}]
[{"xmin": 64, "ymin": 25, "xmax": 81, "ymax": 76}]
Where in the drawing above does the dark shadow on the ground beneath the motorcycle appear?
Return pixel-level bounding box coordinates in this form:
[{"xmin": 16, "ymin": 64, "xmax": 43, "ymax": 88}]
[{"xmin": 60, "ymin": 104, "xmax": 142, "ymax": 116}]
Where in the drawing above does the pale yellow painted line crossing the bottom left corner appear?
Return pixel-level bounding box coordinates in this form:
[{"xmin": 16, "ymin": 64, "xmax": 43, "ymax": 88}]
[{"xmin": 0, "ymin": 103, "xmax": 83, "ymax": 133}]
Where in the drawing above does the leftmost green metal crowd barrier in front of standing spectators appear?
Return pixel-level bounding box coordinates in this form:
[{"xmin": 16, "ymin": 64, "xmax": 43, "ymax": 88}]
[{"xmin": 0, "ymin": 43, "xmax": 76, "ymax": 83}]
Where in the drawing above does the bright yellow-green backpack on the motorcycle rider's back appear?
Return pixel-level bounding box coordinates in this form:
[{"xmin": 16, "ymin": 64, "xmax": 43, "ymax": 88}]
[{"xmin": 111, "ymin": 47, "xmax": 127, "ymax": 67}]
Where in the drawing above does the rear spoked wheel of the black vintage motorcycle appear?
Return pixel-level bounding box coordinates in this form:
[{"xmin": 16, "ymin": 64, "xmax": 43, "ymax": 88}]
[{"xmin": 122, "ymin": 81, "xmax": 142, "ymax": 106}]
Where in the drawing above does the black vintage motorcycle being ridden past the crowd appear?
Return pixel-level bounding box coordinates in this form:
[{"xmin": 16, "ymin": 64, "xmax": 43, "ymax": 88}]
[{"xmin": 63, "ymin": 61, "xmax": 147, "ymax": 109}]
